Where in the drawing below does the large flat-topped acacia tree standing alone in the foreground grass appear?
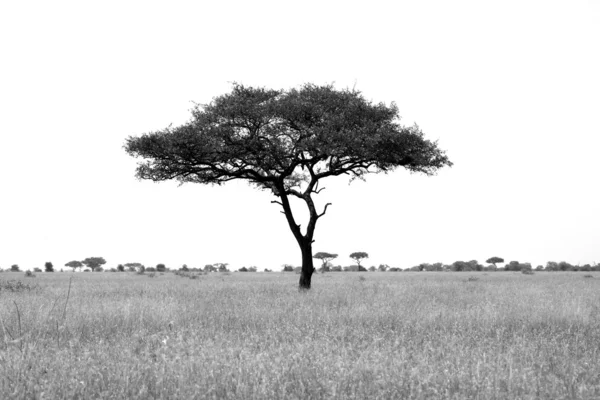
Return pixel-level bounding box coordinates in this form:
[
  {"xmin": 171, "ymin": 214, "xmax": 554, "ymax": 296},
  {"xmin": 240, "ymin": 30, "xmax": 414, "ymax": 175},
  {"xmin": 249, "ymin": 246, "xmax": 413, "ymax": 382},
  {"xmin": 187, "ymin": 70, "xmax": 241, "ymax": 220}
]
[{"xmin": 124, "ymin": 84, "xmax": 452, "ymax": 289}]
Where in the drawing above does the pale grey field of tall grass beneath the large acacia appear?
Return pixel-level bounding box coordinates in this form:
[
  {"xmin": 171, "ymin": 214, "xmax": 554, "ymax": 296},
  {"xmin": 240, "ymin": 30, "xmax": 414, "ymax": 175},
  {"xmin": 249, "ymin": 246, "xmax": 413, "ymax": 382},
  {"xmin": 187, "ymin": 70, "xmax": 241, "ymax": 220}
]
[{"xmin": 0, "ymin": 272, "xmax": 600, "ymax": 399}]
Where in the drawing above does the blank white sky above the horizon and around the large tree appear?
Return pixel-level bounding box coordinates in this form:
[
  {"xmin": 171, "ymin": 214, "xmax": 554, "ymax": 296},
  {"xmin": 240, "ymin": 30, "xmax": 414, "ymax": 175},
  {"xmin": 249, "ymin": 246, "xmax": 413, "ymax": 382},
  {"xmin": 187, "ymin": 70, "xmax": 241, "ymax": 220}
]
[{"xmin": 0, "ymin": 0, "xmax": 600, "ymax": 270}]
